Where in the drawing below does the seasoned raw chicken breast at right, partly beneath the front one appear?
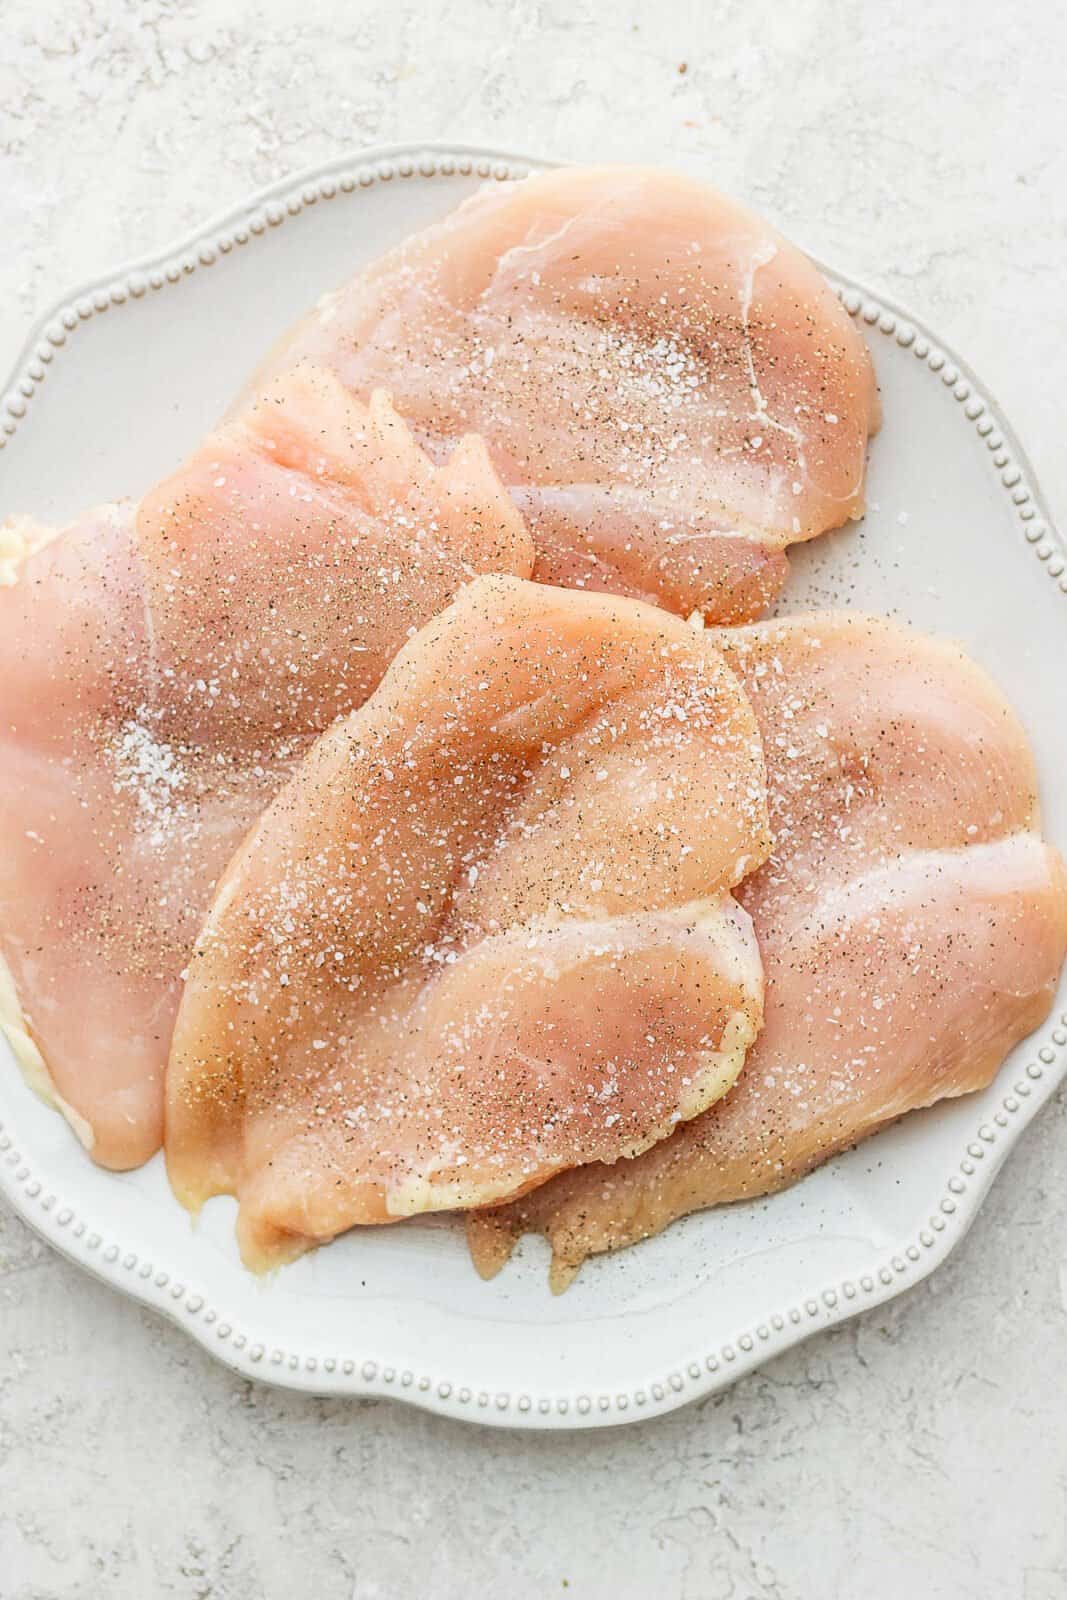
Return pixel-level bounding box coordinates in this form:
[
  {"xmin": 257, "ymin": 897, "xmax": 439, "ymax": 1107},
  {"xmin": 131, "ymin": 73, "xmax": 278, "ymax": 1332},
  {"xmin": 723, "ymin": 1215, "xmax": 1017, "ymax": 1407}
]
[{"xmin": 470, "ymin": 614, "xmax": 1067, "ymax": 1290}]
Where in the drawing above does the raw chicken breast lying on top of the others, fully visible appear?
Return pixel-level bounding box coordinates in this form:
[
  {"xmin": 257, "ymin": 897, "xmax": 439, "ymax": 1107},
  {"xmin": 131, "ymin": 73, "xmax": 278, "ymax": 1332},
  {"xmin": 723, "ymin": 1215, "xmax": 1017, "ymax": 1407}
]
[{"xmin": 166, "ymin": 578, "xmax": 768, "ymax": 1266}]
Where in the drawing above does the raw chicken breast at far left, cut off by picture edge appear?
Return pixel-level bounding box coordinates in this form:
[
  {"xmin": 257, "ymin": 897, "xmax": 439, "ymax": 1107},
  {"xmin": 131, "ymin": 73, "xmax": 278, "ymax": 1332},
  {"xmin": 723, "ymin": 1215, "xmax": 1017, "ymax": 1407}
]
[{"xmin": 0, "ymin": 371, "xmax": 533, "ymax": 1166}]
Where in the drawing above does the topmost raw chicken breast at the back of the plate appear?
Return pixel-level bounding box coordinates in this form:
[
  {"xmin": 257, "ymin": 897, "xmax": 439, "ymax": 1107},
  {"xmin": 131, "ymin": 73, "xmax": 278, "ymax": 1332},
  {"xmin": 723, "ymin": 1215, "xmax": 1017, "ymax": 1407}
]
[{"xmin": 254, "ymin": 166, "xmax": 878, "ymax": 622}]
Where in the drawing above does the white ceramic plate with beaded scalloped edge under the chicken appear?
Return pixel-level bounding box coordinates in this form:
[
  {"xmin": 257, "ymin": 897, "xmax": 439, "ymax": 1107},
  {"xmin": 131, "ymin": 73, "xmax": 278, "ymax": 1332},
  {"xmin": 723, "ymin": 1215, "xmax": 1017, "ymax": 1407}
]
[{"xmin": 0, "ymin": 147, "xmax": 1067, "ymax": 1427}]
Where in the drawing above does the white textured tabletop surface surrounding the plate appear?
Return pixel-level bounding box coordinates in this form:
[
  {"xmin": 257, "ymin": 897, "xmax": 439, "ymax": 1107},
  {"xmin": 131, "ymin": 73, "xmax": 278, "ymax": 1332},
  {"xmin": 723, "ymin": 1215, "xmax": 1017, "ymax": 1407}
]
[{"xmin": 0, "ymin": 0, "xmax": 1067, "ymax": 1600}]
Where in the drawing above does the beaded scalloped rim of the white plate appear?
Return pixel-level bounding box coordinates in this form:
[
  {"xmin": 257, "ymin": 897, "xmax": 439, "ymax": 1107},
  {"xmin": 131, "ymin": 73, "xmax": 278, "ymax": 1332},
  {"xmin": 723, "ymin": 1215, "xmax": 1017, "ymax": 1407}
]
[{"xmin": 0, "ymin": 144, "xmax": 1067, "ymax": 1429}]
